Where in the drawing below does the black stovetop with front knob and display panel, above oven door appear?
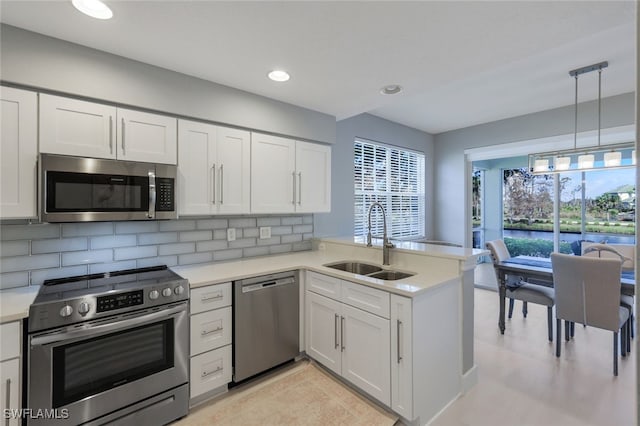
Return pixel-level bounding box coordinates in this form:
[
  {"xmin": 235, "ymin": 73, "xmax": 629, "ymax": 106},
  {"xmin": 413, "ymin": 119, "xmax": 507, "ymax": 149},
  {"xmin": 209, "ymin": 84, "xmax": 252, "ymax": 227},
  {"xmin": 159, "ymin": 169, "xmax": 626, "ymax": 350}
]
[{"xmin": 29, "ymin": 266, "xmax": 189, "ymax": 332}]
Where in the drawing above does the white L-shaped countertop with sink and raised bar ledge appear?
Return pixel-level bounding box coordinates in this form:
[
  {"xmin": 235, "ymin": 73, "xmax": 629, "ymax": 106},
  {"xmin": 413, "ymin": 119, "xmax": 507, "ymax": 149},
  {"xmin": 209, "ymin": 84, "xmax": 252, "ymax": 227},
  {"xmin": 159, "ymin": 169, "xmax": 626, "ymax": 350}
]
[{"xmin": 171, "ymin": 239, "xmax": 484, "ymax": 297}]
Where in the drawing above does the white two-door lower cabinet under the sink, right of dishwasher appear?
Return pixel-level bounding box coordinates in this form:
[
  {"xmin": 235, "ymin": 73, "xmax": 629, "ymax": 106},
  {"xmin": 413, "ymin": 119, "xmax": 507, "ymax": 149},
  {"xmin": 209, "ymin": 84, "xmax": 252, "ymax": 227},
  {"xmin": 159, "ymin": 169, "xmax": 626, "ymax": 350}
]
[{"xmin": 305, "ymin": 272, "xmax": 391, "ymax": 406}]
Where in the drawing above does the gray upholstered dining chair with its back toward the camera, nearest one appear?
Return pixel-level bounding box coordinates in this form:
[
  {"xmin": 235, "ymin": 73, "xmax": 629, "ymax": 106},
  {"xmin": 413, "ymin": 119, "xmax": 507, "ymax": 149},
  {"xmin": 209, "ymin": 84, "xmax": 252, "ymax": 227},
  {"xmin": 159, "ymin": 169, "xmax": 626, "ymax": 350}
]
[{"xmin": 551, "ymin": 253, "xmax": 629, "ymax": 376}]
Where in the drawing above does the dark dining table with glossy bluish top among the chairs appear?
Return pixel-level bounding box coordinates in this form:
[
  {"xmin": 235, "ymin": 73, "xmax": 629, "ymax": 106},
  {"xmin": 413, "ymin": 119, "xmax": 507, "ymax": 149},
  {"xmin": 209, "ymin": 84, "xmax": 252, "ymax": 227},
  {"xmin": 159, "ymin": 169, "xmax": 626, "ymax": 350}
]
[{"xmin": 494, "ymin": 256, "xmax": 636, "ymax": 334}]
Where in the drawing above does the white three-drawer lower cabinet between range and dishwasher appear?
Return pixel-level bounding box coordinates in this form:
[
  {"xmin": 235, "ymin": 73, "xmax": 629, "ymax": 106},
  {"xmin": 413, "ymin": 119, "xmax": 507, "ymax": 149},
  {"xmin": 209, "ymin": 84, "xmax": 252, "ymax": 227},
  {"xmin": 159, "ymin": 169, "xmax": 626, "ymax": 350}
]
[{"xmin": 190, "ymin": 283, "xmax": 233, "ymax": 402}]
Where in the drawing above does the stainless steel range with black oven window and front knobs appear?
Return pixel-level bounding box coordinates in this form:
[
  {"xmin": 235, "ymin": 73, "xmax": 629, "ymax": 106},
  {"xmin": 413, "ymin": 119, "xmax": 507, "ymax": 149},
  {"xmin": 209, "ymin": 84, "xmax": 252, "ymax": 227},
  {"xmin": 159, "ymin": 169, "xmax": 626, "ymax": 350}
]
[{"xmin": 27, "ymin": 266, "xmax": 189, "ymax": 426}]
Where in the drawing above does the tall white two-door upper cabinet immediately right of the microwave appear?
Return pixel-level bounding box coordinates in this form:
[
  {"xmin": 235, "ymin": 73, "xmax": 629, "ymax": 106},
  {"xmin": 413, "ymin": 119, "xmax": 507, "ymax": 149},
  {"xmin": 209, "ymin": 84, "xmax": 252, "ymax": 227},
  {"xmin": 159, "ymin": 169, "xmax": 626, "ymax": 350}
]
[{"xmin": 178, "ymin": 120, "xmax": 251, "ymax": 215}]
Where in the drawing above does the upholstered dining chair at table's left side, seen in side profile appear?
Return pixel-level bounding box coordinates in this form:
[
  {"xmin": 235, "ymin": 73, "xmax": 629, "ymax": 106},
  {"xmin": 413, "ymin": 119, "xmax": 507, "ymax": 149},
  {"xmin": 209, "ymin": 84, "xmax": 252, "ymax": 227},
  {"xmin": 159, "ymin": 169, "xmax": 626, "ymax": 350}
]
[{"xmin": 485, "ymin": 240, "xmax": 555, "ymax": 342}]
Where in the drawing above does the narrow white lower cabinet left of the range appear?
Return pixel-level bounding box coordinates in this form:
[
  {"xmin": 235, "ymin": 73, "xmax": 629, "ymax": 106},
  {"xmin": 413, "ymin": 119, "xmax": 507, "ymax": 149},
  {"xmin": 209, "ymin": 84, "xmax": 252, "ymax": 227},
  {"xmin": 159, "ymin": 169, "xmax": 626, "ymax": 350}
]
[{"xmin": 0, "ymin": 321, "xmax": 22, "ymax": 426}]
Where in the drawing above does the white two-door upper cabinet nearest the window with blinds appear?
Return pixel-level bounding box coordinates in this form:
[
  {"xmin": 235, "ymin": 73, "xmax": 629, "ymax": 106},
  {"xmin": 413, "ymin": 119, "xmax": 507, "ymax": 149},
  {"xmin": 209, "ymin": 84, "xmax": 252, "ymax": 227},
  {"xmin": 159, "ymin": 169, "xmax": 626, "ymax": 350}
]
[{"xmin": 251, "ymin": 133, "xmax": 331, "ymax": 213}]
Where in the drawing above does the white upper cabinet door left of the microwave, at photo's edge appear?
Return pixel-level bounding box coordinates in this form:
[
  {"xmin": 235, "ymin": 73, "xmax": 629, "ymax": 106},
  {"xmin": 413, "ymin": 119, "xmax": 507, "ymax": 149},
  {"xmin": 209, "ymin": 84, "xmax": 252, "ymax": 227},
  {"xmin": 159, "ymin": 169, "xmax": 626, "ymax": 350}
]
[{"xmin": 0, "ymin": 87, "xmax": 38, "ymax": 219}]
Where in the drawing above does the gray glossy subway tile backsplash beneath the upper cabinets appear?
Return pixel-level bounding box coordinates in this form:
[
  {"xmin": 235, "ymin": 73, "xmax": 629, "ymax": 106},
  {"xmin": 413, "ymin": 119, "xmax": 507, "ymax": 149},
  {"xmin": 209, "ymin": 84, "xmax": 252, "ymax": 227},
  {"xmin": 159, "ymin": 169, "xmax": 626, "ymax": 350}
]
[{"xmin": 0, "ymin": 214, "xmax": 313, "ymax": 289}]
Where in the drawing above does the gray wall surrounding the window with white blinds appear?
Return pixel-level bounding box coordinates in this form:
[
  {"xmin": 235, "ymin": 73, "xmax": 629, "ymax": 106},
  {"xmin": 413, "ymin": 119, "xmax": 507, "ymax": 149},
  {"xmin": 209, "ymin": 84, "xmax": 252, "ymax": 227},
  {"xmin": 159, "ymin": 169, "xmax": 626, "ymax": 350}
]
[{"xmin": 314, "ymin": 114, "xmax": 434, "ymax": 237}]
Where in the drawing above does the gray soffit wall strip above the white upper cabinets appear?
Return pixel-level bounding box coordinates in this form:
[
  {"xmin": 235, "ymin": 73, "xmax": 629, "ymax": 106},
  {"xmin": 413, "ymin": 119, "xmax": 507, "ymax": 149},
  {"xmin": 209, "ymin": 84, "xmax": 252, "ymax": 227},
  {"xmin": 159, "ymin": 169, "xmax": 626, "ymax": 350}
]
[{"xmin": 0, "ymin": 24, "xmax": 336, "ymax": 143}]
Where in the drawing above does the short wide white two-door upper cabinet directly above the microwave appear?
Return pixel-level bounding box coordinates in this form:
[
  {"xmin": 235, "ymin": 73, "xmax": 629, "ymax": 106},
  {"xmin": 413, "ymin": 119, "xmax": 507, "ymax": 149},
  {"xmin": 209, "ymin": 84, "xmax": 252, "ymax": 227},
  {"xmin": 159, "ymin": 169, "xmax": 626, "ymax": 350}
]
[{"xmin": 40, "ymin": 94, "xmax": 177, "ymax": 164}]
